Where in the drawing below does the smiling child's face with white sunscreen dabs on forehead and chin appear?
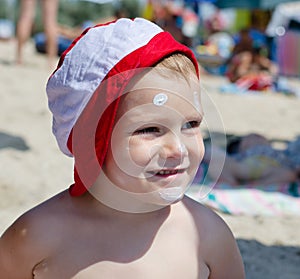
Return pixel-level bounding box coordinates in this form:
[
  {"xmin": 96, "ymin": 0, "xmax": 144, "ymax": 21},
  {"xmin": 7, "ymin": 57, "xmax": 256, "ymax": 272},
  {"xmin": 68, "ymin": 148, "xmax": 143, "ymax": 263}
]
[{"xmin": 103, "ymin": 70, "xmax": 204, "ymax": 207}]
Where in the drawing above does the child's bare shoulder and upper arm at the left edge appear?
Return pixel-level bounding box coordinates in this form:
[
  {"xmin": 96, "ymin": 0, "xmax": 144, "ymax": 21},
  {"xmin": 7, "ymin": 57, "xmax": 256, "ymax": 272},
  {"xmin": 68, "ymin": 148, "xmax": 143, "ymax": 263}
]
[{"xmin": 0, "ymin": 191, "xmax": 69, "ymax": 279}]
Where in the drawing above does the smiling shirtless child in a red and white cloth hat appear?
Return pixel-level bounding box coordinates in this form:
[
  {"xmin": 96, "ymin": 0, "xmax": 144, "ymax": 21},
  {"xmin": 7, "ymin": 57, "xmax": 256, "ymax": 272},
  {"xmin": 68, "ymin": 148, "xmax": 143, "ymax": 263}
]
[{"xmin": 0, "ymin": 18, "xmax": 244, "ymax": 279}]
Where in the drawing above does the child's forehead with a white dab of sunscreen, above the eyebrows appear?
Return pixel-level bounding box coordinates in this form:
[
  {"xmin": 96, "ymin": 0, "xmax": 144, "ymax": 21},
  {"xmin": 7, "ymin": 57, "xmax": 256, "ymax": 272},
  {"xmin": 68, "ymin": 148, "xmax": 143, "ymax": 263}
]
[{"xmin": 118, "ymin": 68, "xmax": 202, "ymax": 120}]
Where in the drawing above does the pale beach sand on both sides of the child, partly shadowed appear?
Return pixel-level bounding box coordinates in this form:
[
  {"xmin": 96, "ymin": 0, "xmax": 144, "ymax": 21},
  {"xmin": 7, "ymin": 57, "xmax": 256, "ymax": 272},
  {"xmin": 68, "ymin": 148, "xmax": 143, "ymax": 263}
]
[{"xmin": 0, "ymin": 40, "xmax": 300, "ymax": 279}]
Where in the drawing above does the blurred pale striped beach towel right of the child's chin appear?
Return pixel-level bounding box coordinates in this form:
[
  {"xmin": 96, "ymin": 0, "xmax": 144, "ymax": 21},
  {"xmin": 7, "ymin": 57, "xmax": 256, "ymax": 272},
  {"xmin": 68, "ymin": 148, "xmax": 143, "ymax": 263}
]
[{"xmin": 187, "ymin": 173, "xmax": 300, "ymax": 216}]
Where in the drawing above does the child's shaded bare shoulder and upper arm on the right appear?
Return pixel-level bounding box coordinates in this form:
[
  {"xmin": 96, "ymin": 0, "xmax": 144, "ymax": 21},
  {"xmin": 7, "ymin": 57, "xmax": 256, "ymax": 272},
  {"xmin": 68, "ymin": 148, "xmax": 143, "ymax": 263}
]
[{"xmin": 183, "ymin": 197, "xmax": 245, "ymax": 279}]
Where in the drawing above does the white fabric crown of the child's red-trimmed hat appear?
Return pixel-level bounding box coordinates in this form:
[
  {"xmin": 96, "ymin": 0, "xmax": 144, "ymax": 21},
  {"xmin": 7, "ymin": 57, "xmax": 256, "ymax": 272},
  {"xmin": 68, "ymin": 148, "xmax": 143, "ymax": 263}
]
[{"xmin": 46, "ymin": 18, "xmax": 163, "ymax": 156}]
